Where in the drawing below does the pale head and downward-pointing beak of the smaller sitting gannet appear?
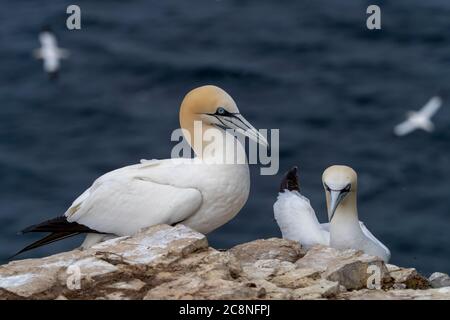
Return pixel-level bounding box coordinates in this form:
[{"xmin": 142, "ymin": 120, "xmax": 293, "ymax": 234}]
[{"xmin": 322, "ymin": 166, "xmax": 358, "ymax": 221}]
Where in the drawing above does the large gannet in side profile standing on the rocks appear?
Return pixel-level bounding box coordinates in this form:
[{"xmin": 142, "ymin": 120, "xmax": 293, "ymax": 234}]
[{"xmin": 15, "ymin": 85, "xmax": 267, "ymax": 253}]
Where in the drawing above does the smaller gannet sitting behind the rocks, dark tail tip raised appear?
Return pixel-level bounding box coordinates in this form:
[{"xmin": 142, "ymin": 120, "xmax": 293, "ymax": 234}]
[{"xmin": 273, "ymin": 166, "xmax": 391, "ymax": 262}]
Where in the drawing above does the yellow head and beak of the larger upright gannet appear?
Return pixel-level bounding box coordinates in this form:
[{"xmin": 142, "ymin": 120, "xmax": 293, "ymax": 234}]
[{"xmin": 180, "ymin": 85, "xmax": 267, "ymax": 150}]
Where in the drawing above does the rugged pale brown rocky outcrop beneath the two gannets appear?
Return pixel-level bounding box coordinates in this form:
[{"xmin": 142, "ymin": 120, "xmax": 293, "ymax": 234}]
[{"xmin": 0, "ymin": 225, "xmax": 450, "ymax": 299}]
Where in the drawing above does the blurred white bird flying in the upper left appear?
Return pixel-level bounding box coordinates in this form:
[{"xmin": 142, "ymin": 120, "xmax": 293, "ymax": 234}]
[{"xmin": 33, "ymin": 27, "xmax": 69, "ymax": 78}]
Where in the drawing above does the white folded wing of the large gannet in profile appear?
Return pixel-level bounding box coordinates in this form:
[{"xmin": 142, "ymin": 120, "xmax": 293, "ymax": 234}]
[{"xmin": 65, "ymin": 169, "xmax": 202, "ymax": 235}]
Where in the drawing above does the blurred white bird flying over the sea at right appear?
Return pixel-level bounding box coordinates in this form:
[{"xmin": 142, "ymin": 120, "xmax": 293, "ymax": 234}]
[{"xmin": 394, "ymin": 96, "xmax": 442, "ymax": 136}]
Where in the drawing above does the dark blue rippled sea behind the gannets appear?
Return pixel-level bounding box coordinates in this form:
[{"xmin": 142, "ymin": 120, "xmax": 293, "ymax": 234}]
[{"xmin": 0, "ymin": 0, "xmax": 450, "ymax": 275}]
